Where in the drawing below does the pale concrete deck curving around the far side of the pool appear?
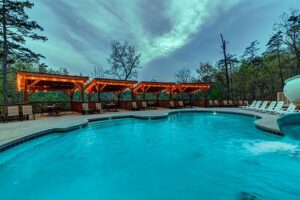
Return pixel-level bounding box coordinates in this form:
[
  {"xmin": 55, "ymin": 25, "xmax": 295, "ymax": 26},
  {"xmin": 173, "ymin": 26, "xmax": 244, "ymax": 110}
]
[{"xmin": 0, "ymin": 108, "xmax": 282, "ymax": 152}]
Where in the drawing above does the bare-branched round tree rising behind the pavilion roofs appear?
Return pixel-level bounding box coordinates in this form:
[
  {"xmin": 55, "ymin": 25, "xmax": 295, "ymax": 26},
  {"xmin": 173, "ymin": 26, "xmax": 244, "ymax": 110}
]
[{"xmin": 107, "ymin": 41, "xmax": 141, "ymax": 80}]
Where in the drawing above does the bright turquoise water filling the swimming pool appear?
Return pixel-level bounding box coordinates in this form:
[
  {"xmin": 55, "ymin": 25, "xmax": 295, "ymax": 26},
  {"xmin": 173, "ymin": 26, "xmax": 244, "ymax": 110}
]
[{"xmin": 0, "ymin": 113, "xmax": 300, "ymax": 200}]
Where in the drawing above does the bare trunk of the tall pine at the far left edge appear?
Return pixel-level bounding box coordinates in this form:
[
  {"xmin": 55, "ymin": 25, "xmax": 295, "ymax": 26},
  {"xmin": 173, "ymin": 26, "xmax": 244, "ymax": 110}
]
[{"xmin": 2, "ymin": 0, "xmax": 8, "ymax": 105}]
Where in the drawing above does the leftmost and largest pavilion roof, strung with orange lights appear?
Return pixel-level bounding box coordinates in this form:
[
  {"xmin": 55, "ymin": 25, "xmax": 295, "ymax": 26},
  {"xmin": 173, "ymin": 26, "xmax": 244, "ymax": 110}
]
[{"xmin": 17, "ymin": 71, "xmax": 88, "ymax": 91}]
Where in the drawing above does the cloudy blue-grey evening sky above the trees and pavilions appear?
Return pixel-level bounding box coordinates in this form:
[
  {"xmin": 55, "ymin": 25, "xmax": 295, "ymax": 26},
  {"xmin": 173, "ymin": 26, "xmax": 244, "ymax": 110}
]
[{"xmin": 27, "ymin": 0, "xmax": 300, "ymax": 81}]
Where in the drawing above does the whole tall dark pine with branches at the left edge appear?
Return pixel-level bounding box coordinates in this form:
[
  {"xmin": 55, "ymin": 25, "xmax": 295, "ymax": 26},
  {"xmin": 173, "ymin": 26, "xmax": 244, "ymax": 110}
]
[{"xmin": 0, "ymin": 0, "xmax": 47, "ymax": 104}]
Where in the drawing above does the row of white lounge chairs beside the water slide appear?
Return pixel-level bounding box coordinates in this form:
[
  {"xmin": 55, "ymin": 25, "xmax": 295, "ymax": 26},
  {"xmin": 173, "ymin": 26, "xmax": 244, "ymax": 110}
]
[{"xmin": 241, "ymin": 101, "xmax": 297, "ymax": 115}]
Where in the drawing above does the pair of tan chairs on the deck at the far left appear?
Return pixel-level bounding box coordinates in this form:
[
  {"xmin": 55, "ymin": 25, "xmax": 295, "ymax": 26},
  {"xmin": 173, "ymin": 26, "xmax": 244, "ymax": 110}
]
[{"xmin": 2, "ymin": 105, "xmax": 35, "ymax": 122}]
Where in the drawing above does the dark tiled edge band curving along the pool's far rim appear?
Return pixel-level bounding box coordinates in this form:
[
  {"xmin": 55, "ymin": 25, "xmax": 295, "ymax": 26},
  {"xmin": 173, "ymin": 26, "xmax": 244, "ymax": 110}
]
[{"xmin": 0, "ymin": 109, "xmax": 283, "ymax": 153}]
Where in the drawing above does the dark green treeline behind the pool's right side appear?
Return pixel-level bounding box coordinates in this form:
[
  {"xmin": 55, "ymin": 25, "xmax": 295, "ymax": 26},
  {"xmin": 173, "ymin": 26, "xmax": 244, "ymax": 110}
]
[{"xmin": 175, "ymin": 10, "xmax": 300, "ymax": 100}]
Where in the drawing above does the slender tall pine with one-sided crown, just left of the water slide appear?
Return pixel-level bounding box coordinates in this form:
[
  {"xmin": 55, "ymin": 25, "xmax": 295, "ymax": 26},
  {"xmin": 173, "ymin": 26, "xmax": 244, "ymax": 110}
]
[{"xmin": 266, "ymin": 31, "xmax": 284, "ymax": 89}]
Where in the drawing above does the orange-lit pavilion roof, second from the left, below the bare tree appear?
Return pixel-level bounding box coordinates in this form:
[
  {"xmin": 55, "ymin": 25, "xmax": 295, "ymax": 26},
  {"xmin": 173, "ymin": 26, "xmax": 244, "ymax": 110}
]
[{"xmin": 85, "ymin": 78, "xmax": 137, "ymax": 94}]
